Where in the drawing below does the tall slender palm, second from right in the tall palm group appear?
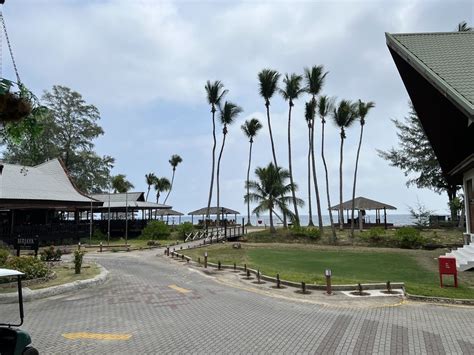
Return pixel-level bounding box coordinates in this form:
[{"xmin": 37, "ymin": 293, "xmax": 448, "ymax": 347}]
[{"xmin": 332, "ymin": 100, "xmax": 357, "ymax": 234}]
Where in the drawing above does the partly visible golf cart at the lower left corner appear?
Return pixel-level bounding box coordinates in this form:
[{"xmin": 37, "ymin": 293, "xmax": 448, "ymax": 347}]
[{"xmin": 0, "ymin": 269, "xmax": 39, "ymax": 355}]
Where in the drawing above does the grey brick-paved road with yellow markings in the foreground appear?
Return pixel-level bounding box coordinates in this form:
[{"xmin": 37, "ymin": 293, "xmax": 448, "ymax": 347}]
[{"xmin": 0, "ymin": 252, "xmax": 474, "ymax": 354}]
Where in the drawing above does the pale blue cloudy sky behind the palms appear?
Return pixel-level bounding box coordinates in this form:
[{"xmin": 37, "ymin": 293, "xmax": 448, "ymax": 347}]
[{"xmin": 2, "ymin": 0, "xmax": 474, "ymax": 214}]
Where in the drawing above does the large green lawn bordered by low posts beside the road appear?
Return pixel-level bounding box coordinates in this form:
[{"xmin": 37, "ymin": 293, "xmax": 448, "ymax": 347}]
[{"xmin": 186, "ymin": 243, "xmax": 474, "ymax": 298}]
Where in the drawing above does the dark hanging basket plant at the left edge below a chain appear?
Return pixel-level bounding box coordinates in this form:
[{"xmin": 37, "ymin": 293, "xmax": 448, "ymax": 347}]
[{"xmin": 0, "ymin": 79, "xmax": 36, "ymax": 123}]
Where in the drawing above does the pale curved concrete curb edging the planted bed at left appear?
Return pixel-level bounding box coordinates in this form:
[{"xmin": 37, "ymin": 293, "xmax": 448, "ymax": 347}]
[{"xmin": 0, "ymin": 264, "xmax": 109, "ymax": 304}]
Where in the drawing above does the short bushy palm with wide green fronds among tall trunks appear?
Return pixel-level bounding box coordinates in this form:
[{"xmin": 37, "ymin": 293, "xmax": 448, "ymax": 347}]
[{"xmin": 245, "ymin": 163, "xmax": 303, "ymax": 233}]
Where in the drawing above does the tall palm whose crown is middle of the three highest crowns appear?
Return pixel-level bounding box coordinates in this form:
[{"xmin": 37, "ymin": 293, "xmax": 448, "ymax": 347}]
[{"xmin": 280, "ymin": 74, "xmax": 304, "ymax": 226}]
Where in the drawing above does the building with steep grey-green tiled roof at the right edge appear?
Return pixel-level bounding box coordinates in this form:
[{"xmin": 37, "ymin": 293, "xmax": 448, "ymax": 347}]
[{"xmin": 386, "ymin": 32, "xmax": 474, "ymax": 267}]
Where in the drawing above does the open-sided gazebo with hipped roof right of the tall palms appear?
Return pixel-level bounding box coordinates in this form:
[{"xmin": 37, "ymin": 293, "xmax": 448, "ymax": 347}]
[{"xmin": 331, "ymin": 197, "xmax": 397, "ymax": 230}]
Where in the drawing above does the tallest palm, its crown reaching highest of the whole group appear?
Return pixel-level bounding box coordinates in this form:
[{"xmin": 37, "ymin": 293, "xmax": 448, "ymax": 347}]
[{"xmin": 305, "ymin": 65, "xmax": 328, "ymax": 235}]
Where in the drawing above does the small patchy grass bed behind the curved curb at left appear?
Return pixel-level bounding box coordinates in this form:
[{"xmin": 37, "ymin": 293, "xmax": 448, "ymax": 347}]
[{"xmin": 0, "ymin": 263, "xmax": 100, "ymax": 293}]
